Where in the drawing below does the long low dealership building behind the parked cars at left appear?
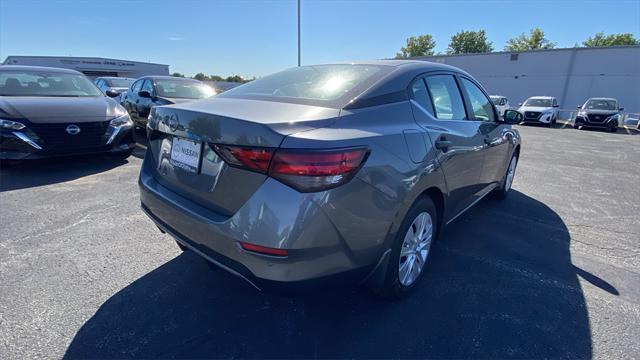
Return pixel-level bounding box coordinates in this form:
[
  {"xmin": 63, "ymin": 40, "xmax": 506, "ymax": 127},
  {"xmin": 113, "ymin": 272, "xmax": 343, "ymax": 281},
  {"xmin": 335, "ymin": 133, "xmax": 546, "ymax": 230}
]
[{"xmin": 3, "ymin": 56, "xmax": 169, "ymax": 78}]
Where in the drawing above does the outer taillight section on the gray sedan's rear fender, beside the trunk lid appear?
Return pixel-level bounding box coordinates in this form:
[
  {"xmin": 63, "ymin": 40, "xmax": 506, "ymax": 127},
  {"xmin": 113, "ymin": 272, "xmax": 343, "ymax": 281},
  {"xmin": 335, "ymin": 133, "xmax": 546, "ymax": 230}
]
[{"xmin": 269, "ymin": 148, "xmax": 368, "ymax": 192}]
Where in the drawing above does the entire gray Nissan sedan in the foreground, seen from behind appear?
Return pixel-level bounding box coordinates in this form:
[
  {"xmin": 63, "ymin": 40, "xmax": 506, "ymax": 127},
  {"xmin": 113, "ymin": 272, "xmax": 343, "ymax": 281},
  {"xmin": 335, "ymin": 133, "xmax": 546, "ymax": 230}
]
[{"xmin": 139, "ymin": 60, "xmax": 522, "ymax": 298}]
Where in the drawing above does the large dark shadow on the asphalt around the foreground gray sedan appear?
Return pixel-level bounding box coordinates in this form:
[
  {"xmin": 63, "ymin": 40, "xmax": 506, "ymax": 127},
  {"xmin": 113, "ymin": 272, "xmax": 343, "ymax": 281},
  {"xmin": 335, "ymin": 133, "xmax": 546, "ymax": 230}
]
[{"xmin": 65, "ymin": 190, "xmax": 600, "ymax": 358}]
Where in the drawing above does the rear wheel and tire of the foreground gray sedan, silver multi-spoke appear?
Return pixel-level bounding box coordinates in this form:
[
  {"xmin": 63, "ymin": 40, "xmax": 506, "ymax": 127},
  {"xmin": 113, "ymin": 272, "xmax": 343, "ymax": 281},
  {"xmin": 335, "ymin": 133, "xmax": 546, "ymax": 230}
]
[{"xmin": 378, "ymin": 197, "xmax": 439, "ymax": 300}]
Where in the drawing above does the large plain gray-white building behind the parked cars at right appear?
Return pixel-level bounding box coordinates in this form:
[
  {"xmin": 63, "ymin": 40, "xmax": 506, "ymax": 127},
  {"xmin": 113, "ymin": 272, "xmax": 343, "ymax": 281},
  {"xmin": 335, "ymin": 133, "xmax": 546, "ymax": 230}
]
[{"xmin": 414, "ymin": 46, "xmax": 640, "ymax": 113}]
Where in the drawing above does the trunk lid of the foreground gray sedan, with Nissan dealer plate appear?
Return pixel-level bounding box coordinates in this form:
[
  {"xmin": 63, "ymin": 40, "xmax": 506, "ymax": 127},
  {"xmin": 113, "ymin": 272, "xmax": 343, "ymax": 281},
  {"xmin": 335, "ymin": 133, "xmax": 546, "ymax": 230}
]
[{"xmin": 147, "ymin": 98, "xmax": 339, "ymax": 216}]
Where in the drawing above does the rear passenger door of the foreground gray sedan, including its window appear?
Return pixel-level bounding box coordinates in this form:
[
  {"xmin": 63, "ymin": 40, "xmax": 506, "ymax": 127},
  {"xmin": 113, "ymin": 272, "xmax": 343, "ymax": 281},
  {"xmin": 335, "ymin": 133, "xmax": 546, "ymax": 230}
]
[{"xmin": 411, "ymin": 73, "xmax": 484, "ymax": 219}]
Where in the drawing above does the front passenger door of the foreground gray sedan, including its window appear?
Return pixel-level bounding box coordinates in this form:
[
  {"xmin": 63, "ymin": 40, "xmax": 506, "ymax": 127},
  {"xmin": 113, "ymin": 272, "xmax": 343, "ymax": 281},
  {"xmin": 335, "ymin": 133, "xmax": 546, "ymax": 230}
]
[{"xmin": 460, "ymin": 77, "xmax": 511, "ymax": 188}]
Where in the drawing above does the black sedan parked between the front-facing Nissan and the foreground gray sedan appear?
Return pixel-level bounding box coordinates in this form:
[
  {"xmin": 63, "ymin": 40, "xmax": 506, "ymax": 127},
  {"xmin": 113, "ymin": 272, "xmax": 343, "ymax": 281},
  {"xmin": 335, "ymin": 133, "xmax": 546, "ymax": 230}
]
[{"xmin": 122, "ymin": 76, "xmax": 216, "ymax": 127}]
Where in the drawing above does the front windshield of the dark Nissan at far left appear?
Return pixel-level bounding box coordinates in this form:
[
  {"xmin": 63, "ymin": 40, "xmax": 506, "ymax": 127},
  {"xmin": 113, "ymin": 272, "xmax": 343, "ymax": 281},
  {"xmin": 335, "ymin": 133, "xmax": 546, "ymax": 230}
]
[{"xmin": 0, "ymin": 70, "xmax": 104, "ymax": 97}]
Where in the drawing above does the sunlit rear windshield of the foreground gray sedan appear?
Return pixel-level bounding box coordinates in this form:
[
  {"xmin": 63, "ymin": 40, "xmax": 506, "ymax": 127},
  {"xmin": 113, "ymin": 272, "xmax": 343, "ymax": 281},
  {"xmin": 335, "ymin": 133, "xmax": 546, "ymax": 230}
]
[{"xmin": 218, "ymin": 64, "xmax": 391, "ymax": 107}]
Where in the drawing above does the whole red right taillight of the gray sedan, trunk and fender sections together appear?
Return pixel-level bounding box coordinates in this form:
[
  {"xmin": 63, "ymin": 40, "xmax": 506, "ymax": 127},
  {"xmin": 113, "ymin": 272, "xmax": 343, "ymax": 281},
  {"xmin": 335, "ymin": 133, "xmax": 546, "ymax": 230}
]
[{"xmin": 212, "ymin": 144, "xmax": 369, "ymax": 192}]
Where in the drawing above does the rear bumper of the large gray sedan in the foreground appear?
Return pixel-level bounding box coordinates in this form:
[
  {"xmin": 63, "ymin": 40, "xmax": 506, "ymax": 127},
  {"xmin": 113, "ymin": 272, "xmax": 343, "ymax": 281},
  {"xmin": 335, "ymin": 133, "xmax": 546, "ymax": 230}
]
[{"xmin": 139, "ymin": 153, "xmax": 383, "ymax": 289}]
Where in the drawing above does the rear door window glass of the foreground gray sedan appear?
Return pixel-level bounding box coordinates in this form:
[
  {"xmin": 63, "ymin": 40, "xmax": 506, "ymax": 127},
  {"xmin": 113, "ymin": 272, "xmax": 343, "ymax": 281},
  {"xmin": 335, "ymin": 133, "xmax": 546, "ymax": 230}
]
[{"xmin": 424, "ymin": 75, "xmax": 467, "ymax": 120}]
